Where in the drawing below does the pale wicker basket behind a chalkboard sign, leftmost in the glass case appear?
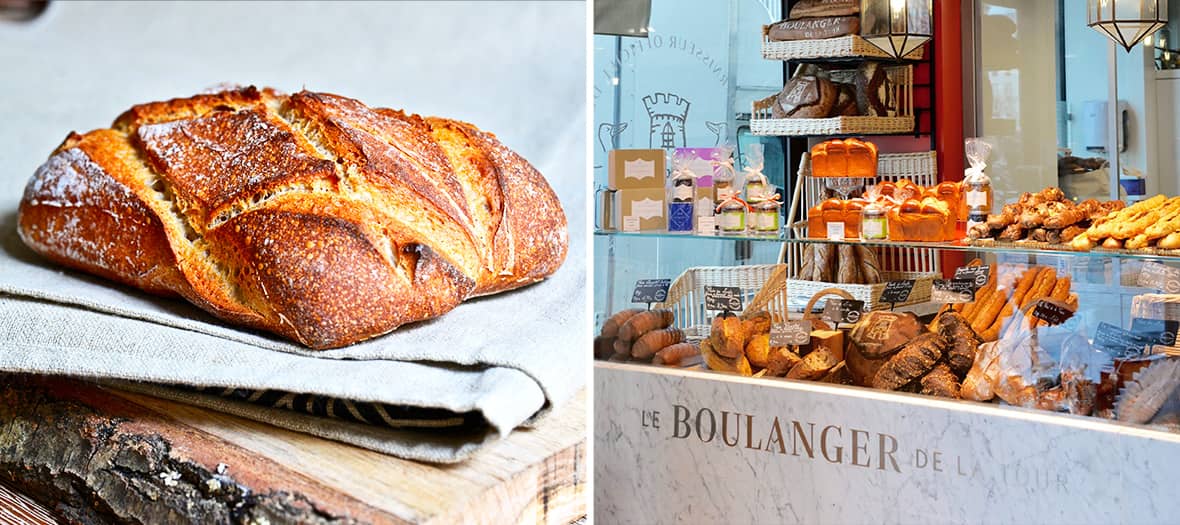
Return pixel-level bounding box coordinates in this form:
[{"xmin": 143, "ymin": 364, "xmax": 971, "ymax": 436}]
[{"xmin": 655, "ymin": 264, "xmax": 787, "ymax": 339}]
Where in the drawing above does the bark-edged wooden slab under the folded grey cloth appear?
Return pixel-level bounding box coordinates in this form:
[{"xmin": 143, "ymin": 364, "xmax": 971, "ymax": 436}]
[{"xmin": 0, "ymin": 374, "xmax": 586, "ymax": 524}]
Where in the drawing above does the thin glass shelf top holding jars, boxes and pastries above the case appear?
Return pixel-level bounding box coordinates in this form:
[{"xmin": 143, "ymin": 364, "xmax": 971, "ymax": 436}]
[{"xmin": 594, "ymin": 230, "xmax": 1180, "ymax": 262}]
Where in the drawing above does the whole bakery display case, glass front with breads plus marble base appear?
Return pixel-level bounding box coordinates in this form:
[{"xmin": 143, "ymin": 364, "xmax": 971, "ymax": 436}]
[{"xmin": 595, "ymin": 224, "xmax": 1180, "ymax": 523}]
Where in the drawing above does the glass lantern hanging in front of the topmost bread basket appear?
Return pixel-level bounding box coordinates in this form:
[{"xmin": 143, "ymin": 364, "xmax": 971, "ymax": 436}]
[{"xmin": 860, "ymin": 0, "xmax": 935, "ymax": 58}]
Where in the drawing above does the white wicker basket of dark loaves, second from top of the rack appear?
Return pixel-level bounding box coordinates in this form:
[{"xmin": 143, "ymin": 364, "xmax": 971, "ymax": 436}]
[{"xmin": 749, "ymin": 65, "xmax": 915, "ymax": 137}]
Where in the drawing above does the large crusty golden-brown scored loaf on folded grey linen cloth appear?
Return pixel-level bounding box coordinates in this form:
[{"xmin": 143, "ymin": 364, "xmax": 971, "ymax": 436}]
[{"xmin": 19, "ymin": 87, "xmax": 568, "ymax": 348}]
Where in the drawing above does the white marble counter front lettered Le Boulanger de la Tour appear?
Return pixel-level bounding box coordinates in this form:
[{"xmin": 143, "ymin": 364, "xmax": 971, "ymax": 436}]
[{"xmin": 594, "ymin": 363, "xmax": 1180, "ymax": 524}]
